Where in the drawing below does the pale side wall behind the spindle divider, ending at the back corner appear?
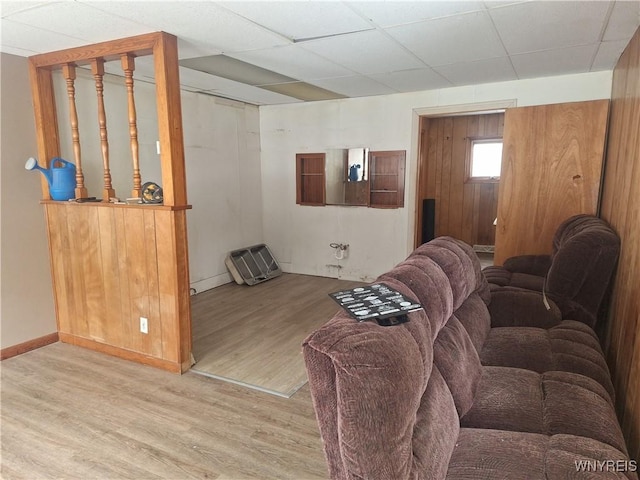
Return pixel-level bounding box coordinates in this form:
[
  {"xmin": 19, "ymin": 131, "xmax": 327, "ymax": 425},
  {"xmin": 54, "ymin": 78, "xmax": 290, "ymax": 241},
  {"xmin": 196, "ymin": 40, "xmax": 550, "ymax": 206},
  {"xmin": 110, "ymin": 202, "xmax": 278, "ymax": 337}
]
[{"xmin": 54, "ymin": 69, "xmax": 262, "ymax": 292}]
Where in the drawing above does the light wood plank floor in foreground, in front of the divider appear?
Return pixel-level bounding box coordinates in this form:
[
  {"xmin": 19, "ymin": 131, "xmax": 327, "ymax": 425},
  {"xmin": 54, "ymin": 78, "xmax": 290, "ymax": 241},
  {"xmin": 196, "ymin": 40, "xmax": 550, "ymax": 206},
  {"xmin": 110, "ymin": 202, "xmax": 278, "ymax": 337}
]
[{"xmin": 0, "ymin": 343, "xmax": 327, "ymax": 480}]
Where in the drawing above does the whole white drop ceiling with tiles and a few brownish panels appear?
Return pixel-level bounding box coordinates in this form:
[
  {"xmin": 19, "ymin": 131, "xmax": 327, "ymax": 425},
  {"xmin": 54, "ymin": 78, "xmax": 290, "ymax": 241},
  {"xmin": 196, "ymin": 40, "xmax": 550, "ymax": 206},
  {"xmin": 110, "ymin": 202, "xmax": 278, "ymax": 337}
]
[{"xmin": 0, "ymin": 0, "xmax": 640, "ymax": 105}]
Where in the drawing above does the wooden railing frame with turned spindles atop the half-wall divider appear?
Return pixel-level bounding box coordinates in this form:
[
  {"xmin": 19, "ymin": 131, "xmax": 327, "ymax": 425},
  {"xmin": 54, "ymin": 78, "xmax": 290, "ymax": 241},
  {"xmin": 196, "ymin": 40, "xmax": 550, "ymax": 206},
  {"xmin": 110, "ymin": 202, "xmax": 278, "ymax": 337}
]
[{"xmin": 29, "ymin": 32, "xmax": 187, "ymax": 206}]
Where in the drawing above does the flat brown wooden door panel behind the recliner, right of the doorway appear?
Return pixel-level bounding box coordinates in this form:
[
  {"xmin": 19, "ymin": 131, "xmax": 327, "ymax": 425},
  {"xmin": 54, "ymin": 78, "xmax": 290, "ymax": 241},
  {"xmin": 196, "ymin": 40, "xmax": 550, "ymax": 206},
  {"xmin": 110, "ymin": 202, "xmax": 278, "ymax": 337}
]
[{"xmin": 494, "ymin": 100, "xmax": 609, "ymax": 265}]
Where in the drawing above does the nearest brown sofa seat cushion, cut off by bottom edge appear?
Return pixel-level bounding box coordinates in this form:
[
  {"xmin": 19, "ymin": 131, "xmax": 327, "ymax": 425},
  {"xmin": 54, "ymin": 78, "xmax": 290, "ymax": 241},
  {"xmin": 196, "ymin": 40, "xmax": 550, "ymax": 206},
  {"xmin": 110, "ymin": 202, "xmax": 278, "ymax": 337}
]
[{"xmin": 448, "ymin": 428, "xmax": 637, "ymax": 480}]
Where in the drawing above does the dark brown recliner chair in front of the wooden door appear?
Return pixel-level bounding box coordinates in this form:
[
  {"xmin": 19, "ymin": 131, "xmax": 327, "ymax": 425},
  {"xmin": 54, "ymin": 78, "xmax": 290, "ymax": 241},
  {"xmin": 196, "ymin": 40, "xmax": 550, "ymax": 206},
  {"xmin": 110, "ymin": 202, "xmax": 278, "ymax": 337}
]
[{"xmin": 483, "ymin": 214, "xmax": 620, "ymax": 330}]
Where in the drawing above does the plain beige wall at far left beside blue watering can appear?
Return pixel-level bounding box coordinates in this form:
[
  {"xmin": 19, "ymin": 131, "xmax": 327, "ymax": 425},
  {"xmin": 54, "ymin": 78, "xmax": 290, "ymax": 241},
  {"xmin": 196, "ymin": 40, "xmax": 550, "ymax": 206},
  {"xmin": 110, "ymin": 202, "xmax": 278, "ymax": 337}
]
[{"xmin": 0, "ymin": 53, "xmax": 57, "ymax": 348}]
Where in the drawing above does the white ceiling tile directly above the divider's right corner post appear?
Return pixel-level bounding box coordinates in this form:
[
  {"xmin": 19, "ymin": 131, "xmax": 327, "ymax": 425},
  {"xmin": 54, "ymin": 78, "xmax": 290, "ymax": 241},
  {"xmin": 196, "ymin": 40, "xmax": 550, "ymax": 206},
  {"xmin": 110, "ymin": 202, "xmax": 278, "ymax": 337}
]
[{"xmin": 86, "ymin": 0, "xmax": 289, "ymax": 54}]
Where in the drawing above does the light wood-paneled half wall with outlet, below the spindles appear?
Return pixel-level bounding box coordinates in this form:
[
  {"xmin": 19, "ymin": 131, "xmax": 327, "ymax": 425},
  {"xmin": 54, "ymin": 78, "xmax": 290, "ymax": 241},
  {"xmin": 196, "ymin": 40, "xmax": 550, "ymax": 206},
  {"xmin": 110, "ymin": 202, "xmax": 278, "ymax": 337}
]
[{"xmin": 44, "ymin": 202, "xmax": 191, "ymax": 372}]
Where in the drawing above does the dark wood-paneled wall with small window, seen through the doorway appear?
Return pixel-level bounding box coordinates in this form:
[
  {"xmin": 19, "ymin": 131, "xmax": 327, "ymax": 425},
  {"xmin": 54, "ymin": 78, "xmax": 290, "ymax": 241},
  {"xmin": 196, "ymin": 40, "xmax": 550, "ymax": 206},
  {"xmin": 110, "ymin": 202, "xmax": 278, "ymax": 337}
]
[{"xmin": 416, "ymin": 113, "xmax": 504, "ymax": 245}]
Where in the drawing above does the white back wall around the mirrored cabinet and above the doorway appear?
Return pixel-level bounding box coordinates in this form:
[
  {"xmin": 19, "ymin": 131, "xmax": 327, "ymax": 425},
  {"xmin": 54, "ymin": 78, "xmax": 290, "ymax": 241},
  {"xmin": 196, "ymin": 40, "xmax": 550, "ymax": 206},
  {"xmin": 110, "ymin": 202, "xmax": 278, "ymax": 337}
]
[{"xmin": 260, "ymin": 72, "xmax": 612, "ymax": 280}]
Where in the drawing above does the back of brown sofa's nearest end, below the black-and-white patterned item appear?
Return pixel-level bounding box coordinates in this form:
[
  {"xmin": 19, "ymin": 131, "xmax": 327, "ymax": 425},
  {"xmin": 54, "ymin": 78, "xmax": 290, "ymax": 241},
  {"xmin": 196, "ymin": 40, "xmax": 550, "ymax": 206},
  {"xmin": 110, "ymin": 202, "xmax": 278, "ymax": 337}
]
[{"xmin": 303, "ymin": 318, "xmax": 428, "ymax": 480}]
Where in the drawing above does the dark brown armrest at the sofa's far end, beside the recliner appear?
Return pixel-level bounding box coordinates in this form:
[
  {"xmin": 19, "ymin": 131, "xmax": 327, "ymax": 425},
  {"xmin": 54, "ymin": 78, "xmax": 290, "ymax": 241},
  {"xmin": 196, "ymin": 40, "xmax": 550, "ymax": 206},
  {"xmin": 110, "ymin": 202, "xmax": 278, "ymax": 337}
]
[{"xmin": 489, "ymin": 287, "xmax": 562, "ymax": 328}]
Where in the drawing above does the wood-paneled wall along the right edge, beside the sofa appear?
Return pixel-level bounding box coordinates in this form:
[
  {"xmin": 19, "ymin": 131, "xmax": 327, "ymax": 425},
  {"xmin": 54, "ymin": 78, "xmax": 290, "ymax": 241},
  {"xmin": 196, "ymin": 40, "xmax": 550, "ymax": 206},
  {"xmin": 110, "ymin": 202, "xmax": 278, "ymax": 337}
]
[{"xmin": 601, "ymin": 25, "xmax": 640, "ymax": 461}]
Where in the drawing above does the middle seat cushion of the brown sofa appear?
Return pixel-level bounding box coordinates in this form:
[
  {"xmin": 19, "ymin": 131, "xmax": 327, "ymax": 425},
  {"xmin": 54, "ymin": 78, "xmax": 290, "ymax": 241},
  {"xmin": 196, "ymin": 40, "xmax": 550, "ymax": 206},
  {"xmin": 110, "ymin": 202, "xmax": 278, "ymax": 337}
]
[{"xmin": 460, "ymin": 367, "xmax": 626, "ymax": 452}]
